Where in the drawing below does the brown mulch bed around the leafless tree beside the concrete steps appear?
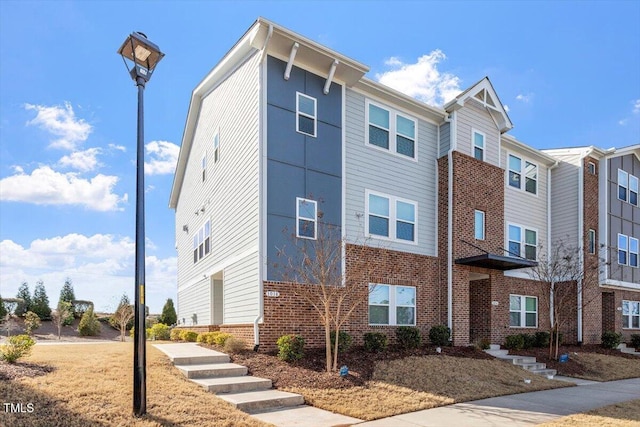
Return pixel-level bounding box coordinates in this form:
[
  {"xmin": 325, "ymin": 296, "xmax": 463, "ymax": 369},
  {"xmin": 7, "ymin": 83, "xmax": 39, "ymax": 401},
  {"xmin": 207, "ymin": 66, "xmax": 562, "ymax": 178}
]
[{"xmin": 231, "ymin": 346, "xmax": 493, "ymax": 389}]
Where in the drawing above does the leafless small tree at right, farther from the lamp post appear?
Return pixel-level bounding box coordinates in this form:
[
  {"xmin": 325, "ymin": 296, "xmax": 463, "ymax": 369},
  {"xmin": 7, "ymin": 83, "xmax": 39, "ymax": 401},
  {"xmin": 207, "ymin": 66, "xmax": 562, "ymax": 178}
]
[{"xmin": 529, "ymin": 240, "xmax": 604, "ymax": 360}]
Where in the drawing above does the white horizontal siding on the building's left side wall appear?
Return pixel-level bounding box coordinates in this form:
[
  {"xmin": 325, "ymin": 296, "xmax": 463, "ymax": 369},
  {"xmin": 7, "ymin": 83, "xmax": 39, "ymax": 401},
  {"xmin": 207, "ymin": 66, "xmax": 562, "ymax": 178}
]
[{"xmin": 176, "ymin": 53, "xmax": 260, "ymax": 324}]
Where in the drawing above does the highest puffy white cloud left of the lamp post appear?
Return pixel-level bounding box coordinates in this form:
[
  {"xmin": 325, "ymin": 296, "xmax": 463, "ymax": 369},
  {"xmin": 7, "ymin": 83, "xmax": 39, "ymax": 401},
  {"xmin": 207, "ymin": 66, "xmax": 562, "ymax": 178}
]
[{"xmin": 25, "ymin": 102, "xmax": 93, "ymax": 150}]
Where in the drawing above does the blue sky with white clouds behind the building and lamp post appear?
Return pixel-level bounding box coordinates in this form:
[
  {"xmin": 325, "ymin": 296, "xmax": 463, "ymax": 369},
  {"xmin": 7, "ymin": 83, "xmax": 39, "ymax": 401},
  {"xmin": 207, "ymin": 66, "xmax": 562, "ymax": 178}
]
[{"xmin": 0, "ymin": 0, "xmax": 640, "ymax": 312}]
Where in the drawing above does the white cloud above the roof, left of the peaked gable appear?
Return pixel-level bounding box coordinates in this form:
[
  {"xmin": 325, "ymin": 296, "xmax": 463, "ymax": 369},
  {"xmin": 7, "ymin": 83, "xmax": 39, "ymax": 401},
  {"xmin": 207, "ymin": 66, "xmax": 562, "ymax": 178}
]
[{"xmin": 376, "ymin": 50, "xmax": 461, "ymax": 105}]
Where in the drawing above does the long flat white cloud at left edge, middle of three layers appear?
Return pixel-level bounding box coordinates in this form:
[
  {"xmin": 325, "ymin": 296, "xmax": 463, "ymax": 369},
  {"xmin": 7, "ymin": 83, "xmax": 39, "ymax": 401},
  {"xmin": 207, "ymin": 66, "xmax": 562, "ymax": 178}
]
[{"xmin": 0, "ymin": 166, "xmax": 128, "ymax": 211}]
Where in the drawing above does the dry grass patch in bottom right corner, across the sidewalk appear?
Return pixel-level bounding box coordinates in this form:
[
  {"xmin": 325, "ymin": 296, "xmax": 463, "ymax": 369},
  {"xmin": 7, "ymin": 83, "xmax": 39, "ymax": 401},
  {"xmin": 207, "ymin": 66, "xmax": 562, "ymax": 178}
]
[{"xmin": 542, "ymin": 400, "xmax": 640, "ymax": 427}]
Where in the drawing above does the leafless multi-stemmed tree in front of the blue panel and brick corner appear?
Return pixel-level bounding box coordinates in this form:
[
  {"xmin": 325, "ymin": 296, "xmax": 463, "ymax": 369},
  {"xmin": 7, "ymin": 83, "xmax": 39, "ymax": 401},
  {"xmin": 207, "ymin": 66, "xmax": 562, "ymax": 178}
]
[{"xmin": 276, "ymin": 224, "xmax": 377, "ymax": 372}]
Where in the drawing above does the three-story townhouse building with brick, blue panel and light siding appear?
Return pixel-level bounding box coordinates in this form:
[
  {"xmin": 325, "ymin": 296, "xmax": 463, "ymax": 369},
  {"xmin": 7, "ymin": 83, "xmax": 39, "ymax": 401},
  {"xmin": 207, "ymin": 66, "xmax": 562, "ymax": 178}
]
[{"xmin": 170, "ymin": 18, "xmax": 640, "ymax": 348}]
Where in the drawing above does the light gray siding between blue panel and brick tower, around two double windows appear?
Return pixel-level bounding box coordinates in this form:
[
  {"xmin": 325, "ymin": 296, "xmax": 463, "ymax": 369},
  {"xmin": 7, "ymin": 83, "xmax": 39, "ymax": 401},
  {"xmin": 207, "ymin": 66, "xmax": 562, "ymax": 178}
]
[{"xmin": 345, "ymin": 89, "xmax": 438, "ymax": 256}]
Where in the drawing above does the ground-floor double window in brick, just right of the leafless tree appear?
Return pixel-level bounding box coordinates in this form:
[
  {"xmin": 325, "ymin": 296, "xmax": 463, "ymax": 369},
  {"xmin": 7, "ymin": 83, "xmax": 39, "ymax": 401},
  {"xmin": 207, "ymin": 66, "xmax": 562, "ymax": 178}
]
[{"xmin": 369, "ymin": 283, "xmax": 416, "ymax": 326}]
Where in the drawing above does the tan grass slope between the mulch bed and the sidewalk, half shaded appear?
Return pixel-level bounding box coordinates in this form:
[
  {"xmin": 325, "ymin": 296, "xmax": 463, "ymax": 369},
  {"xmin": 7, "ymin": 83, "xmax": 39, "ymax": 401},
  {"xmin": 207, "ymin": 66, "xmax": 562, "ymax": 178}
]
[{"xmin": 287, "ymin": 355, "xmax": 570, "ymax": 420}]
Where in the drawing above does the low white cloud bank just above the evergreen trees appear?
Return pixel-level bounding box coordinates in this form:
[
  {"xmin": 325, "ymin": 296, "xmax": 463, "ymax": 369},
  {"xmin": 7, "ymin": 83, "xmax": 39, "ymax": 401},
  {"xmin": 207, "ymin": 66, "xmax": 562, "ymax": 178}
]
[{"xmin": 0, "ymin": 234, "xmax": 177, "ymax": 313}]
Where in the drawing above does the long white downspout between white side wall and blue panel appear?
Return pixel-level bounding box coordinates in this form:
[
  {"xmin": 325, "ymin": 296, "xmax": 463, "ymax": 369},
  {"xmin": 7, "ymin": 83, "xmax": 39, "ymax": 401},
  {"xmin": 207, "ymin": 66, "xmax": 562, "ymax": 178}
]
[{"xmin": 253, "ymin": 24, "xmax": 273, "ymax": 351}]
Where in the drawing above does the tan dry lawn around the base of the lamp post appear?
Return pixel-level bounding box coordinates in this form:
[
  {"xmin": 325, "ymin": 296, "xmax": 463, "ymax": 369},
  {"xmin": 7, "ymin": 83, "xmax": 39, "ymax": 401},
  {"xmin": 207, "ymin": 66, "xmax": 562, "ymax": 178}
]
[{"xmin": 0, "ymin": 343, "xmax": 267, "ymax": 427}]
